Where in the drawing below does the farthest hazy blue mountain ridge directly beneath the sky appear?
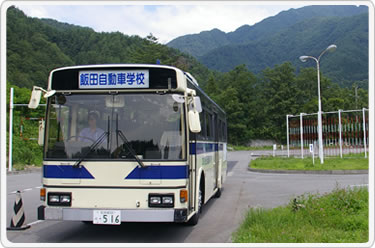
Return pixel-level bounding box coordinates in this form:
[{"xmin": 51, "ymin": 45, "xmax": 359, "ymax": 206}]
[{"xmin": 167, "ymin": 5, "xmax": 368, "ymax": 57}]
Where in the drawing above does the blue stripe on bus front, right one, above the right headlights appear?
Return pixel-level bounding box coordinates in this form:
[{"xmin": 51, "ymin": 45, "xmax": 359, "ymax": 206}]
[{"xmin": 125, "ymin": 165, "xmax": 188, "ymax": 179}]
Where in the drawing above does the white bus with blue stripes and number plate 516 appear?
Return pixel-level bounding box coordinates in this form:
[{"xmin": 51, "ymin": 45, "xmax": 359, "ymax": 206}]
[{"xmin": 29, "ymin": 64, "xmax": 227, "ymax": 225}]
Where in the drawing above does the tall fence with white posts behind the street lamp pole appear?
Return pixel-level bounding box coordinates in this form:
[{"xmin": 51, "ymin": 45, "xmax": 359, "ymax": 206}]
[{"xmin": 286, "ymin": 108, "xmax": 369, "ymax": 158}]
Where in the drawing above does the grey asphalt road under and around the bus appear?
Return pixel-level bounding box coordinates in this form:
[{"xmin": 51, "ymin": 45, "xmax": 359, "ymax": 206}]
[{"xmin": 2, "ymin": 151, "xmax": 368, "ymax": 243}]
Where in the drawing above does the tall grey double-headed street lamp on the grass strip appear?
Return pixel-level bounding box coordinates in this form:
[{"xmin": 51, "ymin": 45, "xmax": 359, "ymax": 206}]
[{"xmin": 299, "ymin": 44, "xmax": 337, "ymax": 164}]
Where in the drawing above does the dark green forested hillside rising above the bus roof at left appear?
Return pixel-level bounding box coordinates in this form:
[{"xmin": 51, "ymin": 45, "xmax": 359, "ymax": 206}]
[{"xmin": 7, "ymin": 7, "xmax": 210, "ymax": 88}]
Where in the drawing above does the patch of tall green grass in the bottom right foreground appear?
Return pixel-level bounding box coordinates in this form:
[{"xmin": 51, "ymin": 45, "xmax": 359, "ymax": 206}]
[{"xmin": 232, "ymin": 188, "xmax": 369, "ymax": 243}]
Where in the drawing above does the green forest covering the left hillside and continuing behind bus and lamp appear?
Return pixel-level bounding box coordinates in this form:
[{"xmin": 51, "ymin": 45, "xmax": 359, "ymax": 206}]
[{"xmin": 7, "ymin": 7, "xmax": 368, "ymax": 167}]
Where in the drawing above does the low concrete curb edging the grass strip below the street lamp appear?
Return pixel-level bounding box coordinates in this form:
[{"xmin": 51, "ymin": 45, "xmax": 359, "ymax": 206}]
[{"xmin": 247, "ymin": 167, "xmax": 368, "ymax": 175}]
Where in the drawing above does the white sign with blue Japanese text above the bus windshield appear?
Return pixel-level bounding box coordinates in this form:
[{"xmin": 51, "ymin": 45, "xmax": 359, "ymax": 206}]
[{"xmin": 78, "ymin": 70, "xmax": 149, "ymax": 89}]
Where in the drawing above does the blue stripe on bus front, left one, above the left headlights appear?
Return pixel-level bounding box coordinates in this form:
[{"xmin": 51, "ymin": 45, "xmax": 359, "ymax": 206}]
[{"xmin": 43, "ymin": 165, "xmax": 94, "ymax": 179}]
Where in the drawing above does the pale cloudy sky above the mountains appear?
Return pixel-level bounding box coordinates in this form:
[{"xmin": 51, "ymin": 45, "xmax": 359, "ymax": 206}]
[{"xmin": 16, "ymin": 1, "xmax": 303, "ymax": 44}]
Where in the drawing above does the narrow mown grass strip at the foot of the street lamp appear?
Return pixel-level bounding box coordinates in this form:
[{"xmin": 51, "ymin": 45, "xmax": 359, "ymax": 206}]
[{"xmin": 249, "ymin": 156, "xmax": 369, "ymax": 170}]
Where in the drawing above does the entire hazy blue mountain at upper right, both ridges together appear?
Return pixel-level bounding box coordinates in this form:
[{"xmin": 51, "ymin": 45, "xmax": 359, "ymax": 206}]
[{"xmin": 167, "ymin": 6, "xmax": 368, "ymax": 86}]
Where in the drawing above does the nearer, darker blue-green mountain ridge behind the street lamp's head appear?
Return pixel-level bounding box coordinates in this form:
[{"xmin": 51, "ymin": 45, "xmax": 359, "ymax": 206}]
[{"xmin": 200, "ymin": 14, "xmax": 368, "ymax": 85}]
